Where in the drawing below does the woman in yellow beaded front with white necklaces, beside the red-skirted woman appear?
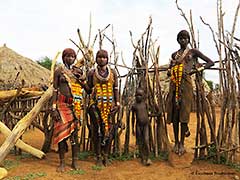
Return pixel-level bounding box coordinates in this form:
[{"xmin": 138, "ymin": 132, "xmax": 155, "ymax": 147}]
[{"xmin": 83, "ymin": 49, "xmax": 120, "ymax": 165}]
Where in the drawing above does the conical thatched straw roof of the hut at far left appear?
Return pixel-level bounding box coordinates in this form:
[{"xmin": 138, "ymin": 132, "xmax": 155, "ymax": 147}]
[{"xmin": 0, "ymin": 45, "xmax": 50, "ymax": 90}]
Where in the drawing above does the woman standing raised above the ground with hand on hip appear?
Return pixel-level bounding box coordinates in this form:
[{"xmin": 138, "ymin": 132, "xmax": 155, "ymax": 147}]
[{"xmin": 166, "ymin": 30, "xmax": 214, "ymax": 155}]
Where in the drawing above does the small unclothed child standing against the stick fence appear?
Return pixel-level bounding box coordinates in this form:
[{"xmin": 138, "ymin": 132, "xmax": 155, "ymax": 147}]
[{"xmin": 132, "ymin": 88, "xmax": 152, "ymax": 166}]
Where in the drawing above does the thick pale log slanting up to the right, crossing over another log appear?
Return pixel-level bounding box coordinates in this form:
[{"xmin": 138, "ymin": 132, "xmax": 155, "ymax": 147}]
[{"xmin": 0, "ymin": 86, "xmax": 53, "ymax": 163}]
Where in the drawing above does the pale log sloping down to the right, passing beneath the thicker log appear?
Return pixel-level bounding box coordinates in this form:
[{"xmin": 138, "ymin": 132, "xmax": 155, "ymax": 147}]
[{"xmin": 0, "ymin": 121, "xmax": 45, "ymax": 159}]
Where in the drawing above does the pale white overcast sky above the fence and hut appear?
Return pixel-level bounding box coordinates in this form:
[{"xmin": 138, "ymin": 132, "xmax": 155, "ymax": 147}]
[{"xmin": 0, "ymin": 0, "xmax": 240, "ymax": 82}]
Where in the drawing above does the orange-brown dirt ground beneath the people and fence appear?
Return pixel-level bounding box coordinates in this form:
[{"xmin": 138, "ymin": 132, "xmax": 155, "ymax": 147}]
[{"xmin": 0, "ymin": 109, "xmax": 240, "ymax": 180}]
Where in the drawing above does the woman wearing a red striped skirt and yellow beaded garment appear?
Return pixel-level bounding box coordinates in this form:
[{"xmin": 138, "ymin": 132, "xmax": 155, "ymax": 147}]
[{"xmin": 52, "ymin": 48, "xmax": 83, "ymax": 172}]
